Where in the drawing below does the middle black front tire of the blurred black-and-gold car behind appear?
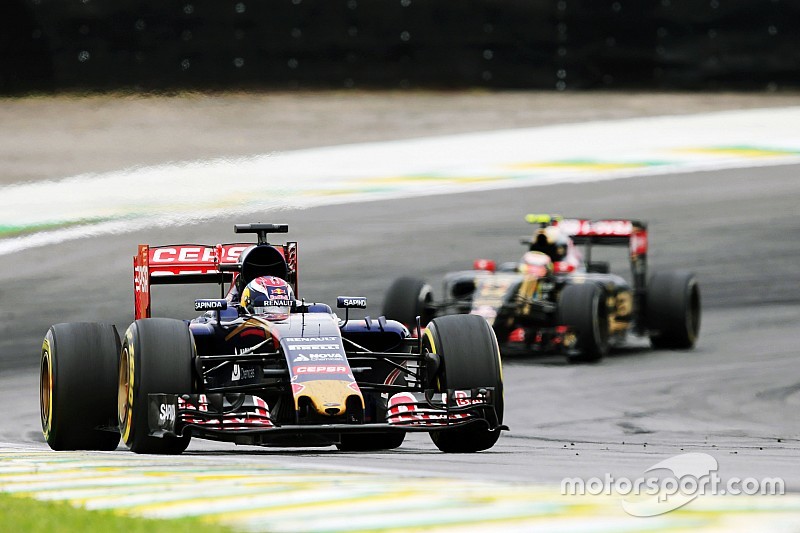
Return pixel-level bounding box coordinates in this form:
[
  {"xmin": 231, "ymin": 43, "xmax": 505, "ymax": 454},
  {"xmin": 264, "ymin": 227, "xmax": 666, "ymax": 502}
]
[{"xmin": 558, "ymin": 283, "xmax": 609, "ymax": 363}]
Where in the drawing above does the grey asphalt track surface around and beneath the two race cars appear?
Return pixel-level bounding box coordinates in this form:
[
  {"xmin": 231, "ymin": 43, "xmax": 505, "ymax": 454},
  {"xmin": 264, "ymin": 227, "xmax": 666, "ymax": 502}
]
[{"xmin": 0, "ymin": 156, "xmax": 800, "ymax": 491}]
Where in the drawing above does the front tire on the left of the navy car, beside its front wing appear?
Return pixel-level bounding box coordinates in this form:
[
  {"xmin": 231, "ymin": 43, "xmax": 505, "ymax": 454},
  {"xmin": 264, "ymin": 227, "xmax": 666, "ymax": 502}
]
[{"xmin": 117, "ymin": 318, "xmax": 194, "ymax": 454}]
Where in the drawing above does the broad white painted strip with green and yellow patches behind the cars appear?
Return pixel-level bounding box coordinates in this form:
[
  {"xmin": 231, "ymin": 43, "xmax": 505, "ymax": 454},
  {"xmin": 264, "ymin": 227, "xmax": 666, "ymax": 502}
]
[{"xmin": 0, "ymin": 107, "xmax": 800, "ymax": 255}]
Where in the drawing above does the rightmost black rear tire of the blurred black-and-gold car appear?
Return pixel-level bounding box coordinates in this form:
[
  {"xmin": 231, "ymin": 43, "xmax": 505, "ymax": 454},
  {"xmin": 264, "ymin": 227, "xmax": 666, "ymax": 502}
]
[{"xmin": 647, "ymin": 270, "xmax": 700, "ymax": 350}]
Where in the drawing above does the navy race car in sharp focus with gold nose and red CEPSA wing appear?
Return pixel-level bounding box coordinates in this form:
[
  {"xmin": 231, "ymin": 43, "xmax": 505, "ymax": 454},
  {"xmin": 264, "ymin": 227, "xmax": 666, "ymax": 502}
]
[{"xmin": 40, "ymin": 224, "xmax": 507, "ymax": 454}]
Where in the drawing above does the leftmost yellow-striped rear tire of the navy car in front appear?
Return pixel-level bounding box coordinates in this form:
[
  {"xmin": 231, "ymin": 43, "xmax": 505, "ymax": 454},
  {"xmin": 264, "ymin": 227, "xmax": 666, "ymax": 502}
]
[{"xmin": 39, "ymin": 323, "xmax": 120, "ymax": 450}]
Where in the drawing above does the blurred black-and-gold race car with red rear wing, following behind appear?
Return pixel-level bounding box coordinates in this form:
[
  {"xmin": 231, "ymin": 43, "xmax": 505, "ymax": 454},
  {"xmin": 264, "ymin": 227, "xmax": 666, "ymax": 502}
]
[{"xmin": 383, "ymin": 215, "xmax": 700, "ymax": 361}]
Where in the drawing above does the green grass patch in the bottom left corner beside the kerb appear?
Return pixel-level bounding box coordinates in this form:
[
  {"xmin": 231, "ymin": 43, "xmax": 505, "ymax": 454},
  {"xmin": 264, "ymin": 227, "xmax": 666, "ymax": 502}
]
[{"xmin": 0, "ymin": 493, "xmax": 238, "ymax": 533}]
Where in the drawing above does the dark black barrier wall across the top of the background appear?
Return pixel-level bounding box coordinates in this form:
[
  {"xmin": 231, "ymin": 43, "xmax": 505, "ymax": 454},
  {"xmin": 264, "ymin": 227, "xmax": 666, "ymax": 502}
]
[{"xmin": 0, "ymin": 0, "xmax": 800, "ymax": 93}]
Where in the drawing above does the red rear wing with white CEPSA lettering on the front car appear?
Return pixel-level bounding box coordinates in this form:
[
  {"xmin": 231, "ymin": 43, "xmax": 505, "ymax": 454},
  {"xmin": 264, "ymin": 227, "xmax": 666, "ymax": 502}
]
[{"xmin": 133, "ymin": 242, "xmax": 297, "ymax": 320}]
